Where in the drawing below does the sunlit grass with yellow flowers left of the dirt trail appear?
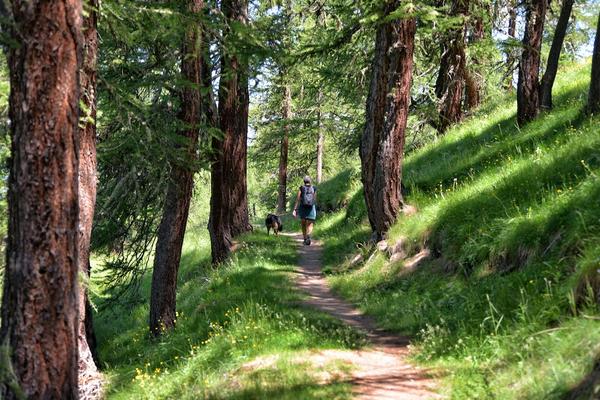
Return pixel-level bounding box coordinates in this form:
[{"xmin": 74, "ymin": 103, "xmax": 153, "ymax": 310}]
[{"xmin": 95, "ymin": 205, "xmax": 364, "ymax": 399}]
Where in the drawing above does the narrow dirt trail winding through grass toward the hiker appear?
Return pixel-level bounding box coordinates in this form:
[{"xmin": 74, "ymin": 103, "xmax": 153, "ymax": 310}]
[{"xmin": 293, "ymin": 235, "xmax": 441, "ymax": 400}]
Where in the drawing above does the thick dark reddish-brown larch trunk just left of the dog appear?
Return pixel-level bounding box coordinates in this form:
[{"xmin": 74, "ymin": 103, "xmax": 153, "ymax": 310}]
[{"xmin": 208, "ymin": 0, "xmax": 252, "ymax": 264}]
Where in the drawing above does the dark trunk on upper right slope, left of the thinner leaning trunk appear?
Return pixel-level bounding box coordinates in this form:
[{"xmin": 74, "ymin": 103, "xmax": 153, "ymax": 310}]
[{"xmin": 517, "ymin": 0, "xmax": 548, "ymax": 125}]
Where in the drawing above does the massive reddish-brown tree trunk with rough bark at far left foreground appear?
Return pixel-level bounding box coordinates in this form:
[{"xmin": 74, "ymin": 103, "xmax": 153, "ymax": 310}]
[{"xmin": 0, "ymin": 0, "xmax": 83, "ymax": 399}]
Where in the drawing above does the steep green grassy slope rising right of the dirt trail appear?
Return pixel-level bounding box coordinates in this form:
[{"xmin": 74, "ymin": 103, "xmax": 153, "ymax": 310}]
[{"xmin": 318, "ymin": 61, "xmax": 600, "ymax": 399}]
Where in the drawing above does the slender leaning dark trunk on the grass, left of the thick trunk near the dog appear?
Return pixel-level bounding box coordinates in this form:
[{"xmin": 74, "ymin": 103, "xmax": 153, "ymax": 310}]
[{"xmin": 150, "ymin": 0, "xmax": 204, "ymax": 336}]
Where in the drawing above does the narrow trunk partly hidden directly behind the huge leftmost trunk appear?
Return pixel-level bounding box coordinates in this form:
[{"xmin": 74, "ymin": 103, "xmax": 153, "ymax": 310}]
[{"xmin": 78, "ymin": 0, "xmax": 101, "ymax": 397}]
